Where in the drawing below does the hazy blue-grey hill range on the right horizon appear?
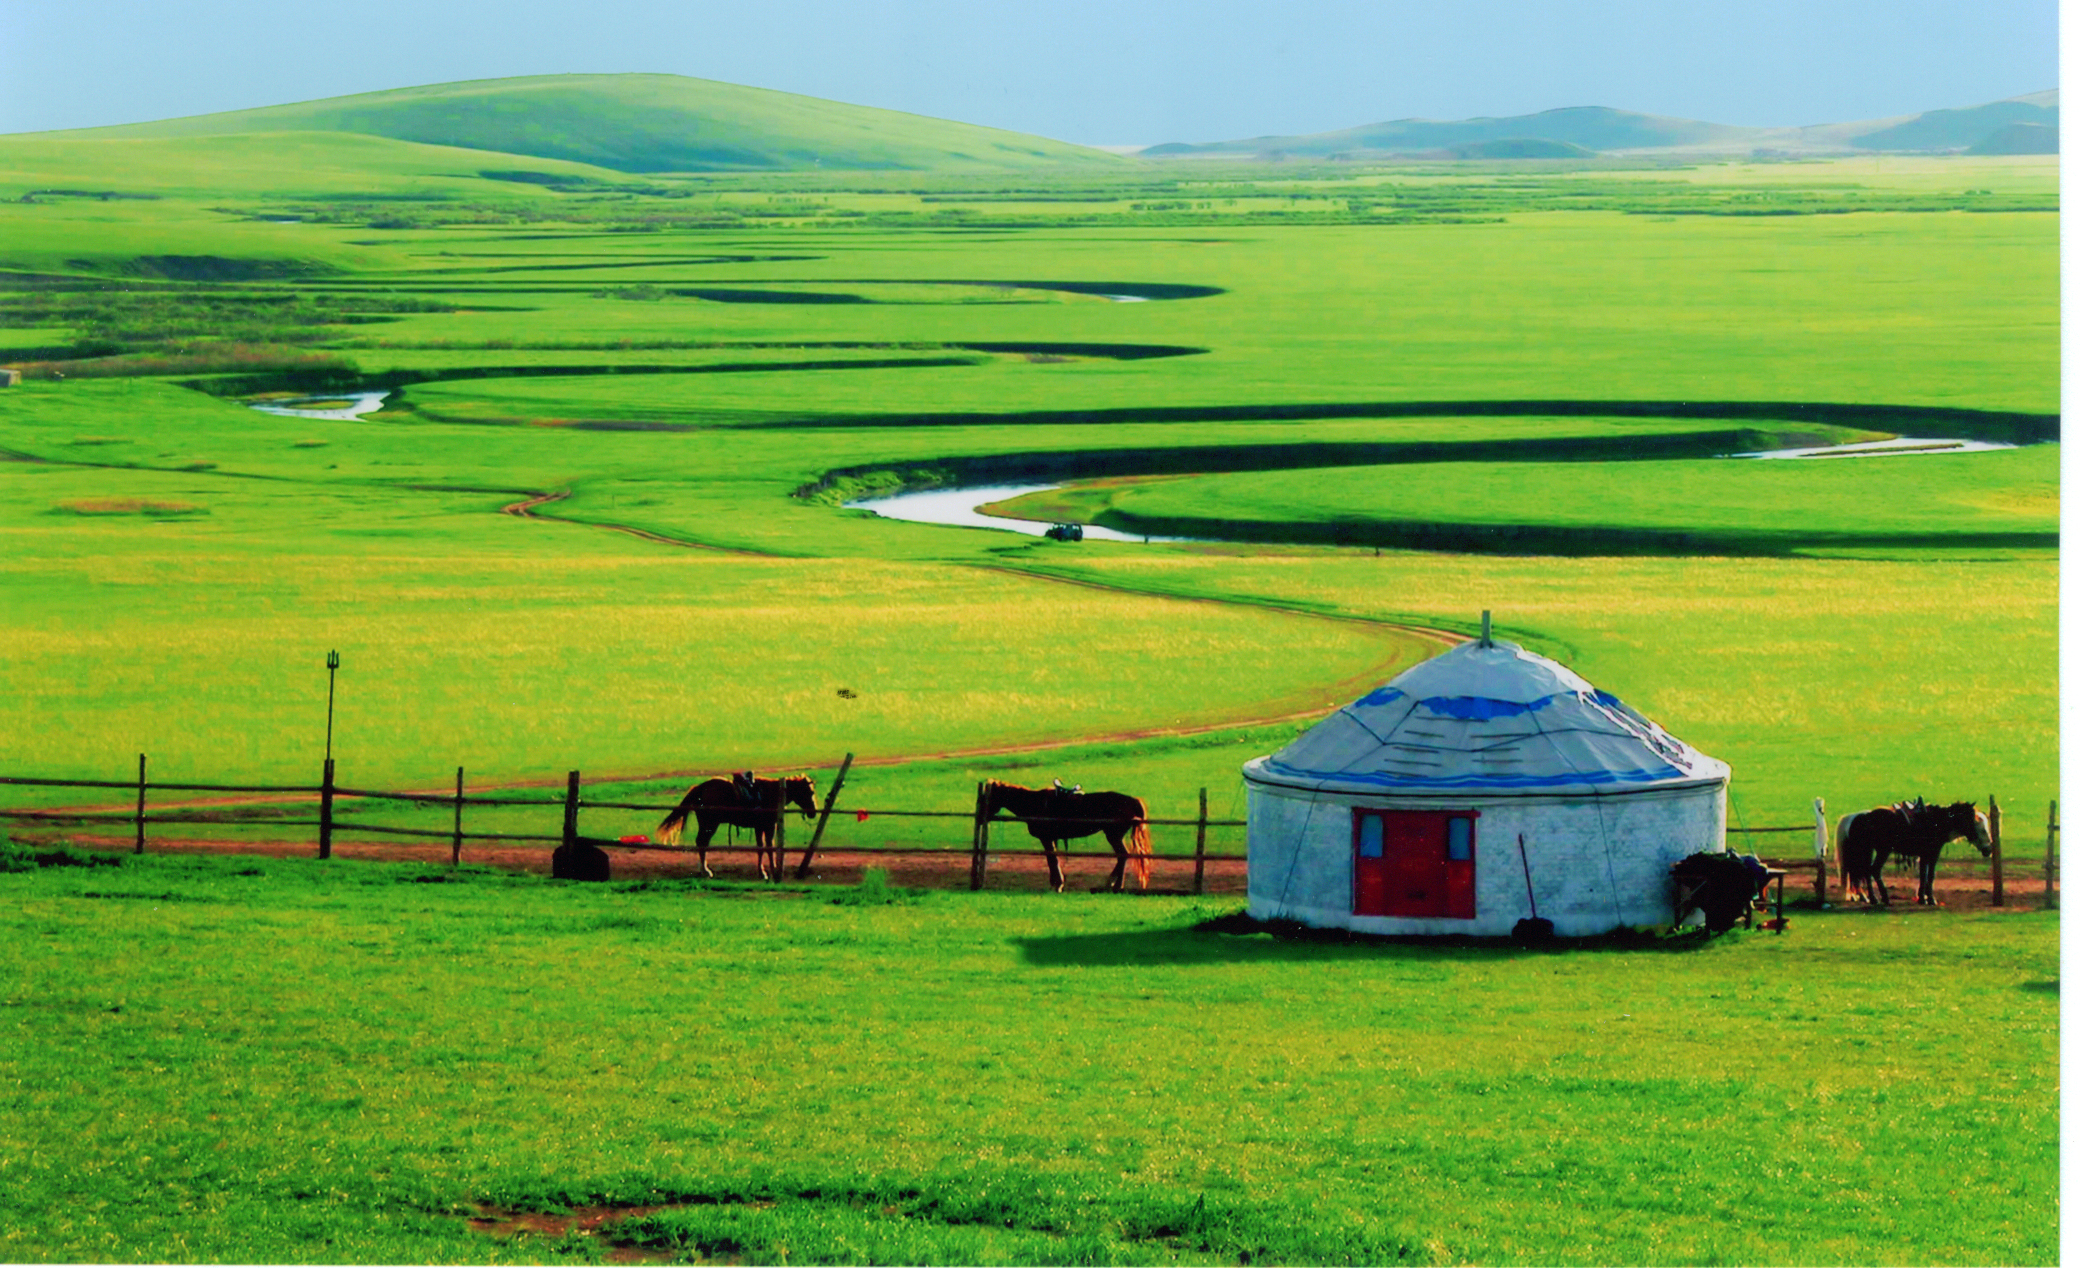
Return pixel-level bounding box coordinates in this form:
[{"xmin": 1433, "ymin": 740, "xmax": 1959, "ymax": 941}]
[{"xmin": 1140, "ymin": 89, "xmax": 2059, "ymax": 160}]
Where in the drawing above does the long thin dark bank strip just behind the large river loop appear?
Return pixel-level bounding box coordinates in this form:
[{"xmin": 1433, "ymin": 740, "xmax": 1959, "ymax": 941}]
[{"xmin": 773, "ymin": 401, "xmax": 2059, "ymax": 446}]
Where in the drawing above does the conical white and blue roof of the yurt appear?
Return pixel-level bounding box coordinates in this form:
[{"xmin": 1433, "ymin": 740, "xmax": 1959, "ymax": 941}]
[{"xmin": 1242, "ymin": 638, "xmax": 1733, "ymax": 796}]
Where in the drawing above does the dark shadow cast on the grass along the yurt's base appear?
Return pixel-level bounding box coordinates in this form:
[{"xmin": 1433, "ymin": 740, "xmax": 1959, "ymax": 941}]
[{"xmin": 1013, "ymin": 913, "xmax": 1718, "ymax": 967}]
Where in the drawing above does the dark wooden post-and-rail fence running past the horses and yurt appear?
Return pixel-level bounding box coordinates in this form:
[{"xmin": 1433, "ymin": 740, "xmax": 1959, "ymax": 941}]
[{"xmin": 0, "ymin": 752, "xmax": 2059, "ymax": 908}]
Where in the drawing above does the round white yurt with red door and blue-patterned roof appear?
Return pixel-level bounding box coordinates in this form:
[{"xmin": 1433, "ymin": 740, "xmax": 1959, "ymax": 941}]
[{"xmin": 1242, "ymin": 613, "xmax": 1733, "ymax": 937}]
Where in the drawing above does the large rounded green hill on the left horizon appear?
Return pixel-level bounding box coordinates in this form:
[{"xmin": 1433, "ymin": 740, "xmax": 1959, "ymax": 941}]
[{"xmin": 20, "ymin": 75, "xmax": 1121, "ymax": 173}]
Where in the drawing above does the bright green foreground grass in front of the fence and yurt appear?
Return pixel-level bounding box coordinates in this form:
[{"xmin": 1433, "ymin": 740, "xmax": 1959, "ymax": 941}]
[{"xmin": 0, "ymin": 843, "xmax": 2057, "ymax": 1264}]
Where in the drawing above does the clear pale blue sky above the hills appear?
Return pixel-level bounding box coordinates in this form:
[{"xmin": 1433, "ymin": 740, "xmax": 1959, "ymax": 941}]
[{"xmin": 0, "ymin": 0, "xmax": 2059, "ymax": 143}]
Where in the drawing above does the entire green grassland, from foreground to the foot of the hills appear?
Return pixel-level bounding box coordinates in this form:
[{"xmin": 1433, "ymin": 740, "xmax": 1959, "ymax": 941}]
[{"xmin": 0, "ymin": 143, "xmax": 2059, "ymax": 1262}]
